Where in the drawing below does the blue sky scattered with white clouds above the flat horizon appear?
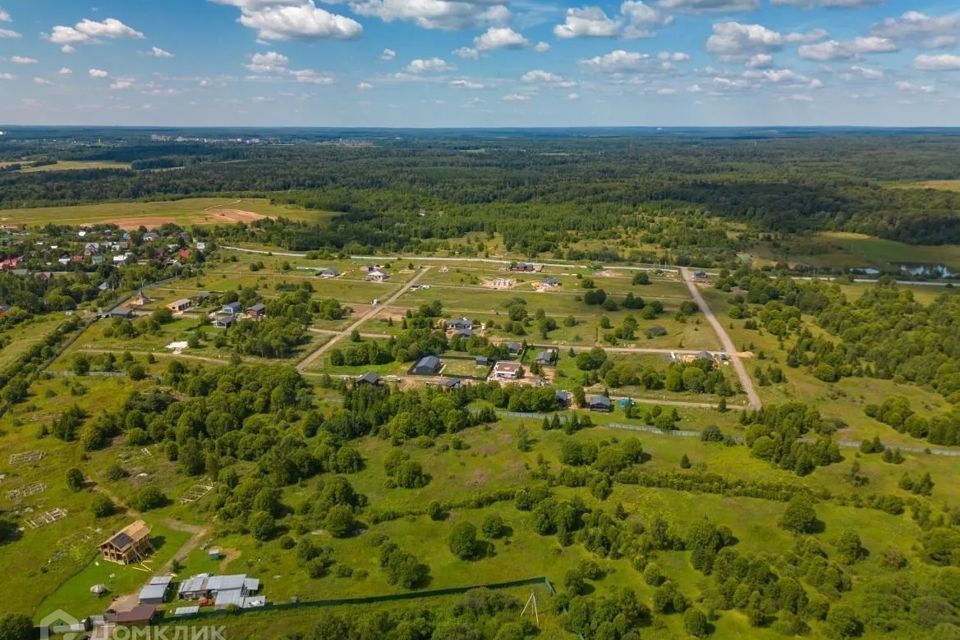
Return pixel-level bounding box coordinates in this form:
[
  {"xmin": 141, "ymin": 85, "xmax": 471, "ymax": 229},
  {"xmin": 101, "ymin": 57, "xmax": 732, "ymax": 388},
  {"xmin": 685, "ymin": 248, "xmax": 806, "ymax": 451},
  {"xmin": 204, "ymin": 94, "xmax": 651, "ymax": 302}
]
[{"xmin": 0, "ymin": 0, "xmax": 960, "ymax": 127}]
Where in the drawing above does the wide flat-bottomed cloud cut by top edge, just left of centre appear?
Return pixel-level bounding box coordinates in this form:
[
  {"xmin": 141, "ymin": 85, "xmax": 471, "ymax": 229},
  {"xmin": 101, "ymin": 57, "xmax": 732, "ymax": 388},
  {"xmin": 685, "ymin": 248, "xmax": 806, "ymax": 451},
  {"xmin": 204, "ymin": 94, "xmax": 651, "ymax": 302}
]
[{"xmin": 350, "ymin": 0, "xmax": 510, "ymax": 30}]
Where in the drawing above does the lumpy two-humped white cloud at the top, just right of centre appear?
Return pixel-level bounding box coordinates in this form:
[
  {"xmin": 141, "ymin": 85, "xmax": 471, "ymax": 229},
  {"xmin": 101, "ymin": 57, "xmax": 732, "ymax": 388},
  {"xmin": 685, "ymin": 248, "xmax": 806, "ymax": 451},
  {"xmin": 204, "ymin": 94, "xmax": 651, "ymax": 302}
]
[{"xmin": 553, "ymin": 0, "xmax": 673, "ymax": 39}]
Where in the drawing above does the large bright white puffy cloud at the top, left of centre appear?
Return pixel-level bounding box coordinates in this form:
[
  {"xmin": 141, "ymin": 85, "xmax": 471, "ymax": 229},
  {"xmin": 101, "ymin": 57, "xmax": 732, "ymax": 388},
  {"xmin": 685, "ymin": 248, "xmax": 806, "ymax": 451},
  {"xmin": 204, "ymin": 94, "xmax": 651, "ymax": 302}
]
[{"xmin": 240, "ymin": 0, "xmax": 363, "ymax": 41}]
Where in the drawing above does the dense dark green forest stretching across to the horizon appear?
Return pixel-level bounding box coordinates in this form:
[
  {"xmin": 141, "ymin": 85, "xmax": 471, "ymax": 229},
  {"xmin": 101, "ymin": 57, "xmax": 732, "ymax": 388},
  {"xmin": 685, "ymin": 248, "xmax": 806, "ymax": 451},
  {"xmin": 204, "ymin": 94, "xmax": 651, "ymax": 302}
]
[{"xmin": 0, "ymin": 132, "xmax": 960, "ymax": 249}]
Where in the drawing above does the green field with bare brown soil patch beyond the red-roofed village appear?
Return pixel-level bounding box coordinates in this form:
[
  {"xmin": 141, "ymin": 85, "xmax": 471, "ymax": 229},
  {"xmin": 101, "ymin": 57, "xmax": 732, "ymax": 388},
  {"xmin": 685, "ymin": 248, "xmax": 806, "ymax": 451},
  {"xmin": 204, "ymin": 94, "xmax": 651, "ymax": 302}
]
[{"xmin": 0, "ymin": 198, "xmax": 328, "ymax": 229}]
